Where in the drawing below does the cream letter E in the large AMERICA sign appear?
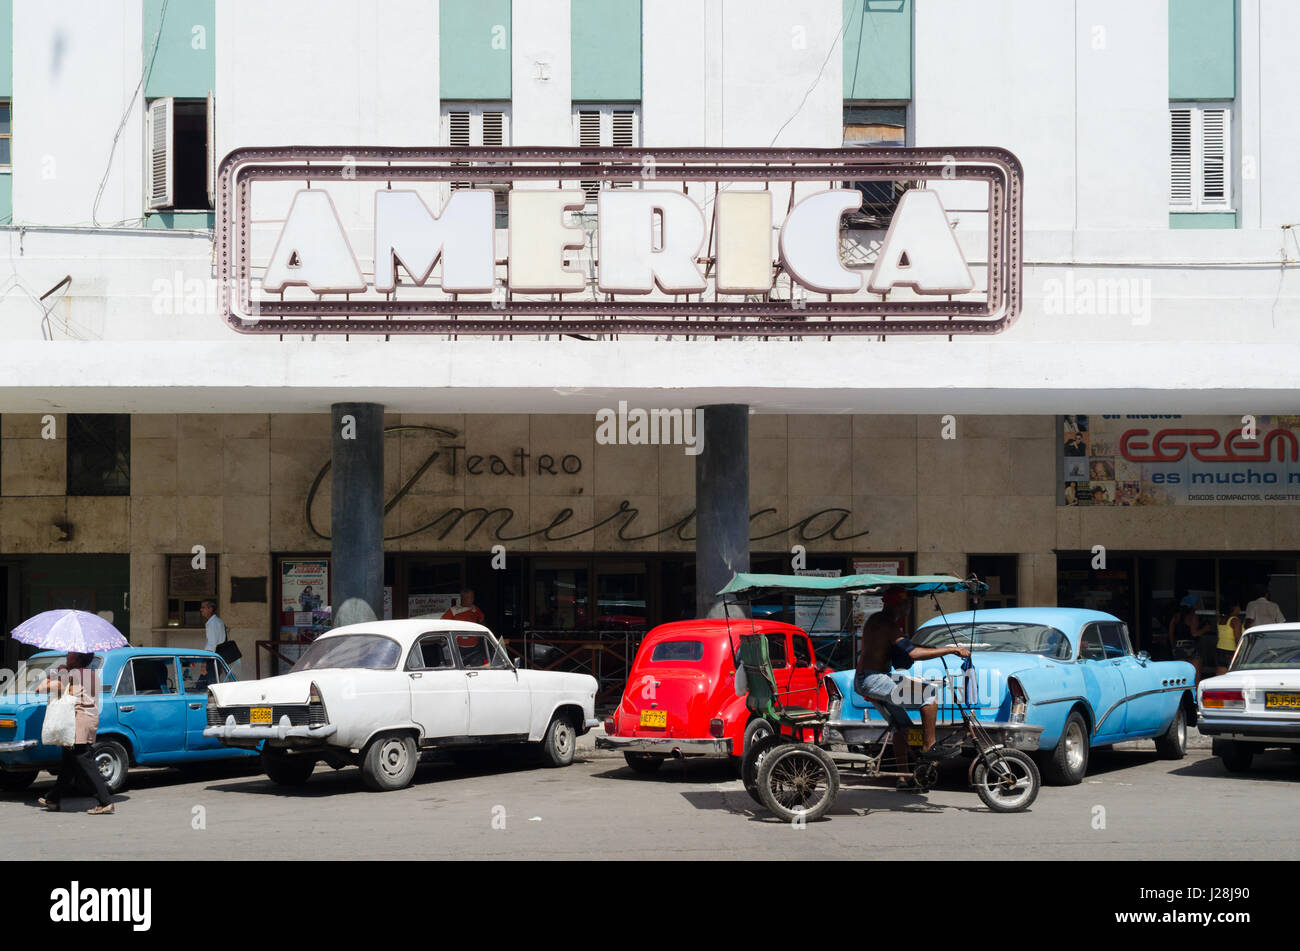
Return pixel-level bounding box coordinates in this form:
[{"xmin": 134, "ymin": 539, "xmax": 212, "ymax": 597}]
[{"xmin": 508, "ymin": 188, "xmax": 586, "ymax": 294}]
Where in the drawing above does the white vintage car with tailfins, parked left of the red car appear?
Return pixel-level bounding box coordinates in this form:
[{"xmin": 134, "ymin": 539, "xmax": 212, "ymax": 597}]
[{"xmin": 203, "ymin": 618, "xmax": 599, "ymax": 791}]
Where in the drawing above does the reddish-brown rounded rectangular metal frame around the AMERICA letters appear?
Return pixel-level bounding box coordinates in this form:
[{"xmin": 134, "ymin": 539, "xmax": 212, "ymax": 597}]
[{"xmin": 216, "ymin": 147, "xmax": 1023, "ymax": 336}]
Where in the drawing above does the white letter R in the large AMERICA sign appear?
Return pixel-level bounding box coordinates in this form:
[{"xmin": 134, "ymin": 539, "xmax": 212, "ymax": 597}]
[{"xmin": 595, "ymin": 188, "xmax": 707, "ymax": 294}]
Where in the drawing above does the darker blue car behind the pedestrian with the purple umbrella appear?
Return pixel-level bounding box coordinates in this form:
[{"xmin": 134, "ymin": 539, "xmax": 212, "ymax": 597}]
[{"xmin": 0, "ymin": 647, "xmax": 257, "ymax": 793}]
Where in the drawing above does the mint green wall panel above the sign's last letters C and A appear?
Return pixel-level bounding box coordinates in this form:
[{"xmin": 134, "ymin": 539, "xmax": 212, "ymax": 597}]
[{"xmin": 841, "ymin": 0, "xmax": 915, "ymax": 100}]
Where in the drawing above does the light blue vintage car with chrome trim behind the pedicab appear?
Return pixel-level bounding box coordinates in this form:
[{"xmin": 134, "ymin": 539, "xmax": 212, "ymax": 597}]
[{"xmin": 829, "ymin": 608, "xmax": 1196, "ymax": 785}]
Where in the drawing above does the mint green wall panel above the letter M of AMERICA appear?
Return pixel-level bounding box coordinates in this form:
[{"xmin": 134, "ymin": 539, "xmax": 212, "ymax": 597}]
[{"xmin": 438, "ymin": 0, "xmax": 510, "ymax": 99}]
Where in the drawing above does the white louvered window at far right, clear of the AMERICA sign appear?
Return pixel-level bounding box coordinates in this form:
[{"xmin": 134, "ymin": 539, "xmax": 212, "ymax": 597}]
[{"xmin": 1169, "ymin": 105, "xmax": 1232, "ymax": 212}]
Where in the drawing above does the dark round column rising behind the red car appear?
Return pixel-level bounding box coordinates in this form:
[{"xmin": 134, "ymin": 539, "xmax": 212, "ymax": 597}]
[{"xmin": 696, "ymin": 403, "xmax": 749, "ymax": 617}]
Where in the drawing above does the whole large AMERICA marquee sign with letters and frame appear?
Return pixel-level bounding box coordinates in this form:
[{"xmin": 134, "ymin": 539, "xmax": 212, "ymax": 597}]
[{"xmin": 216, "ymin": 147, "xmax": 1022, "ymax": 336}]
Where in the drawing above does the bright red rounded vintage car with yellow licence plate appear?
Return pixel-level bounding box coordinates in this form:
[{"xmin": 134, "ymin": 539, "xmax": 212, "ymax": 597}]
[{"xmin": 595, "ymin": 618, "xmax": 828, "ymax": 773}]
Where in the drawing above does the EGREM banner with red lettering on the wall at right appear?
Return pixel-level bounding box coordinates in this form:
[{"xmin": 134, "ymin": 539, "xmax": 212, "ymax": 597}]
[{"xmin": 1061, "ymin": 414, "xmax": 1300, "ymax": 505}]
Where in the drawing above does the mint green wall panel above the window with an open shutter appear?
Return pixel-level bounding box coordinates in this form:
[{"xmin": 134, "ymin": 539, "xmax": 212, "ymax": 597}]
[{"xmin": 140, "ymin": 0, "xmax": 217, "ymax": 99}]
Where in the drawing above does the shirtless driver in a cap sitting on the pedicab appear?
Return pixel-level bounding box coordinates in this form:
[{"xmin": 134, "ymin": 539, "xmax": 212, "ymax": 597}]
[{"xmin": 853, "ymin": 587, "xmax": 971, "ymax": 789}]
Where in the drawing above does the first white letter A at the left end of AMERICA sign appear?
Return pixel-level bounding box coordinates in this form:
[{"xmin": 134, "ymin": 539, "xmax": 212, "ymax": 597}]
[{"xmin": 261, "ymin": 188, "xmax": 365, "ymax": 294}]
